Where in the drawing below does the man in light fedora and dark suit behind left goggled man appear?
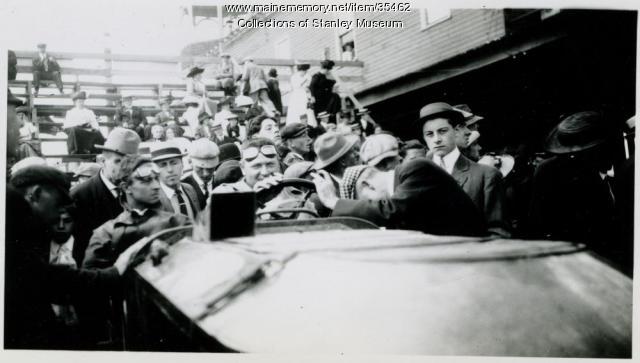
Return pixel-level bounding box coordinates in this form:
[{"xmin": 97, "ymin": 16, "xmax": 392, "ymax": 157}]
[{"xmin": 71, "ymin": 127, "xmax": 140, "ymax": 264}]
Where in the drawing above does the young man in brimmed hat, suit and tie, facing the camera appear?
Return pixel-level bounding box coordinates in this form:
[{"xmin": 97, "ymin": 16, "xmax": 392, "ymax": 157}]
[{"xmin": 417, "ymin": 102, "xmax": 511, "ymax": 238}]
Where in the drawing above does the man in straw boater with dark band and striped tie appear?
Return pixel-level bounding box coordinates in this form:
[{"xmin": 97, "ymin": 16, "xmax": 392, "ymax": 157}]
[{"xmin": 151, "ymin": 141, "xmax": 200, "ymax": 220}]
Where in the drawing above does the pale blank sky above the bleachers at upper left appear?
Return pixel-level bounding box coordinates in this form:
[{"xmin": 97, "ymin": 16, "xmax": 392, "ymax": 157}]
[{"xmin": 0, "ymin": 0, "xmax": 220, "ymax": 56}]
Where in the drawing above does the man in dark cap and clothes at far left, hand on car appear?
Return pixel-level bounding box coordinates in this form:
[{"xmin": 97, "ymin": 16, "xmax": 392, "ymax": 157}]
[{"xmin": 4, "ymin": 165, "xmax": 148, "ymax": 349}]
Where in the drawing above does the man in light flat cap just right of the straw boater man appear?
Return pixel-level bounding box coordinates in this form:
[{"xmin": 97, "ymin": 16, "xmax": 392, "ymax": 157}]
[{"xmin": 182, "ymin": 139, "xmax": 220, "ymax": 210}]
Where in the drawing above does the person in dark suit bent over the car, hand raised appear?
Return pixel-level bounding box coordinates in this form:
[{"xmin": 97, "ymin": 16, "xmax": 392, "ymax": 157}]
[{"xmin": 313, "ymin": 159, "xmax": 487, "ymax": 236}]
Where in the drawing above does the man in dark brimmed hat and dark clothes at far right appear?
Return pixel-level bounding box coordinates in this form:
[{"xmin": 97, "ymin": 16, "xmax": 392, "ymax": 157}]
[{"xmin": 529, "ymin": 112, "xmax": 618, "ymax": 268}]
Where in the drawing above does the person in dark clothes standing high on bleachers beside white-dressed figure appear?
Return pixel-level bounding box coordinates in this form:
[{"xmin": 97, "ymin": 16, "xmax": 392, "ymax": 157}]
[{"xmin": 309, "ymin": 59, "xmax": 342, "ymax": 117}]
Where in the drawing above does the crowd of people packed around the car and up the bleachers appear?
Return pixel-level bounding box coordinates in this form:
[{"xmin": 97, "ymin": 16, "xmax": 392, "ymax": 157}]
[{"xmin": 5, "ymin": 47, "xmax": 635, "ymax": 349}]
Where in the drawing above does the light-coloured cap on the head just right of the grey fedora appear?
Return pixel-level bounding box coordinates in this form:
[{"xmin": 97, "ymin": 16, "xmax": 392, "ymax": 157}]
[{"xmin": 360, "ymin": 134, "xmax": 401, "ymax": 171}]
